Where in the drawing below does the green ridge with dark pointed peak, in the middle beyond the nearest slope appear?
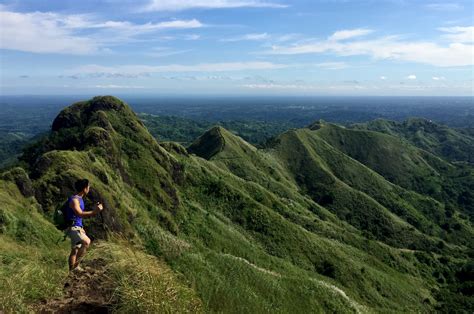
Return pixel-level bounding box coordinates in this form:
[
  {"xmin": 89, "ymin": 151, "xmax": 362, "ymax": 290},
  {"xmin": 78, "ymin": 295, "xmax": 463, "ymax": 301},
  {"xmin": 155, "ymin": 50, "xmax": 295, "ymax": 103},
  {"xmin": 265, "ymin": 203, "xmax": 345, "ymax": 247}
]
[{"xmin": 189, "ymin": 124, "xmax": 470, "ymax": 249}]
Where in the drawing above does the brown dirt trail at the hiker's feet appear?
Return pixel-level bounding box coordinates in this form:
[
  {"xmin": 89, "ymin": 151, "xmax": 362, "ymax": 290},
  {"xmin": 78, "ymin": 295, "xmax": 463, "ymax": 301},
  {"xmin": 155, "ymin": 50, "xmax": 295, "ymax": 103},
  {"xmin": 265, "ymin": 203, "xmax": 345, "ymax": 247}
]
[{"xmin": 31, "ymin": 259, "xmax": 113, "ymax": 313}]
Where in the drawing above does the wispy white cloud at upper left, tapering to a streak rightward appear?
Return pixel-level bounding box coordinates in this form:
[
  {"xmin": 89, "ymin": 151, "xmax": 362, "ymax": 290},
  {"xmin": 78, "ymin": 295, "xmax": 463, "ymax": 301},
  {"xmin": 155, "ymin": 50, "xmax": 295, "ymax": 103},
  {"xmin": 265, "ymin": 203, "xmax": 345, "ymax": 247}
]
[{"xmin": 0, "ymin": 7, "xmax": 203, "ymax": 55}]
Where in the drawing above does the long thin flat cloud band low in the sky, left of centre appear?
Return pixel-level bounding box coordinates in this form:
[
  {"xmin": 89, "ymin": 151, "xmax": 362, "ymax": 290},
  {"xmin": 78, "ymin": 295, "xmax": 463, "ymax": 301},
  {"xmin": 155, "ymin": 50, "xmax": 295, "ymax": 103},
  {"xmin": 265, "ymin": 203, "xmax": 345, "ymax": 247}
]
[{"xmin": 69, "ymin": 62, "xmax": 287, "ymax": 77}]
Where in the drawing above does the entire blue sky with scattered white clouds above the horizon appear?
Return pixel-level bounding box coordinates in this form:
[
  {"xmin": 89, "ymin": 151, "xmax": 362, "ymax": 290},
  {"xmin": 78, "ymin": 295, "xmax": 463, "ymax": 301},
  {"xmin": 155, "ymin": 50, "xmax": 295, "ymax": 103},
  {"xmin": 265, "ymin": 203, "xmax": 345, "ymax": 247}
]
[{"xmin": 0, "ymin": 0, "xmax": 474, "ymax": 96}]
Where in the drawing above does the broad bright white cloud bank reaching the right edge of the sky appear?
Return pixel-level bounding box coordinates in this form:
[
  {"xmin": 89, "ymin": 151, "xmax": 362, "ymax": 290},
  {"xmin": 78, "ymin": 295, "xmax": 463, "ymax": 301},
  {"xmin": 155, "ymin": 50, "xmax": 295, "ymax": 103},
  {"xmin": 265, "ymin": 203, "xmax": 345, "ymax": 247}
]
[{"xmin": 267, "ymin": 28, "xmax": 474, "ymax": 67}]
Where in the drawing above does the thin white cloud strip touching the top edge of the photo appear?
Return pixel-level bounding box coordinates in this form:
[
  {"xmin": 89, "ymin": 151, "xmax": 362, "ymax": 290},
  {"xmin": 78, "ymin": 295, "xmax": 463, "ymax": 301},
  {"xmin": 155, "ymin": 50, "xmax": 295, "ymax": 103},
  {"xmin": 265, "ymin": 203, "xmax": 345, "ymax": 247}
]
[{"xmin": 142, "ymin": 0, "xmax": 288, "ymax": 11}]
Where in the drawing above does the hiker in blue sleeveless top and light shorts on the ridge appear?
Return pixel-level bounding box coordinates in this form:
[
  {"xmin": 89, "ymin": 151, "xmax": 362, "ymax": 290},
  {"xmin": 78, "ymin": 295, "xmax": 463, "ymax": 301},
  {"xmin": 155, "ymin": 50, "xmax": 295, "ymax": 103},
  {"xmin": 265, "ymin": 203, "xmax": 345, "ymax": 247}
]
[{"xmin": 66, "ymin": 179, "xmax": 104, "ymax": 270}]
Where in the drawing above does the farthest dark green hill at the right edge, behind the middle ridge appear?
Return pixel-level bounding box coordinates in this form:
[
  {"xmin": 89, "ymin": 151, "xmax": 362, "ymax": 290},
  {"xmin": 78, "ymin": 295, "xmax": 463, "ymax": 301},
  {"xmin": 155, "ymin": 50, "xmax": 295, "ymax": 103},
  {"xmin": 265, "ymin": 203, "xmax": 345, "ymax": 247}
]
[{"xmin": 326, "ymin": 119, "xmax": 474, "ymax": 222}]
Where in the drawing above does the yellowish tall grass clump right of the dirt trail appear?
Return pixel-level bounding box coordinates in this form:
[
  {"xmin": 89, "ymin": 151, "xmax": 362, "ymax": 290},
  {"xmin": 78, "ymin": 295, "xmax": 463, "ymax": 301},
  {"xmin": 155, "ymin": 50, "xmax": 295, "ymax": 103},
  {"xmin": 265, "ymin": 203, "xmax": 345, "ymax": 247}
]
[{"xmin": 88, "ymin": 242, "xmax": 202, "ymax": 313}]
